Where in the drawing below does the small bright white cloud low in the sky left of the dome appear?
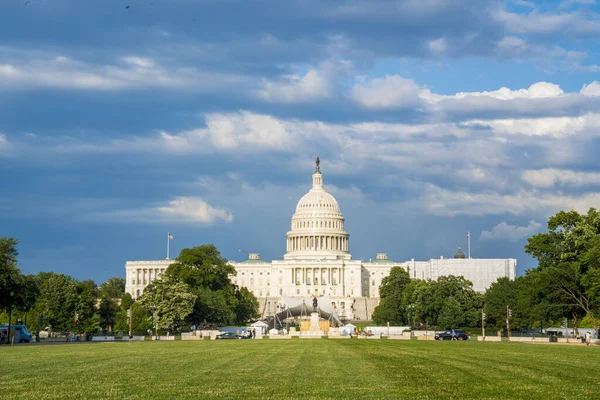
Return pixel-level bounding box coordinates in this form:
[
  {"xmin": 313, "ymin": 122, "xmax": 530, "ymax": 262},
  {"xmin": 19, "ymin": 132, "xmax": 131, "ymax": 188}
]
[{"xmin": 102, "ymin": 196, "xmax": 233, "ymax": 225}]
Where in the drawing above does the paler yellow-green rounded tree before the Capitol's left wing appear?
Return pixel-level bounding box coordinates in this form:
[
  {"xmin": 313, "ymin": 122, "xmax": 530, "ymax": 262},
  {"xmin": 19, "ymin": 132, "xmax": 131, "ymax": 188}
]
[{"xmin": 139, "ymin": 279, "xmax": 196, "ymax": 331}]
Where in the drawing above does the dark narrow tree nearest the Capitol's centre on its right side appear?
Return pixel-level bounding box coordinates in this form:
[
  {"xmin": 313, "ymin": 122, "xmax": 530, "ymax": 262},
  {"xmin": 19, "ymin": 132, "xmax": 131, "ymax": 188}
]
[{"xmin": 372, "ymin": 267, "xmax": 411, "ymax": 325}]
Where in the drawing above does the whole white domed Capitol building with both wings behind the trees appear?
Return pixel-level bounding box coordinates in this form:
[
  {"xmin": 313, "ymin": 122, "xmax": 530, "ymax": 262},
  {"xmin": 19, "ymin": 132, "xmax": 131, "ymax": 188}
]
[{"xmin": 125, "ymin": 158, "xmax": 517, "ymax": 320}]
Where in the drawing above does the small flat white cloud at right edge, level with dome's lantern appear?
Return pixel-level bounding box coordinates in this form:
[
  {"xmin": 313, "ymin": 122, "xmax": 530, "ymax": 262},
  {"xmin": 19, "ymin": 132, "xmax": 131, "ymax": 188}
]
[{"xmin": 521, "ymin": 168, "xmax": 600, "ymax": 188}]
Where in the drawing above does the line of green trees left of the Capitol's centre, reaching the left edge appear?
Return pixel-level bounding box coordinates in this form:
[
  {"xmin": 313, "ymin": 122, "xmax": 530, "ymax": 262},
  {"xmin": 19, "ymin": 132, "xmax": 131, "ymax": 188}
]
[{"xmin": 0, "ymin": 237, "xmax": 258, "ymax": 335}]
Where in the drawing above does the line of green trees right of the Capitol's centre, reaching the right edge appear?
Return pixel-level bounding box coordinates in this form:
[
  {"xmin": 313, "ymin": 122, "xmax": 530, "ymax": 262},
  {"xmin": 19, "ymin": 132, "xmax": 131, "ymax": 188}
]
[{"xmin": 373, "ymin": 208, "xmax": 600, "ymax": 331}]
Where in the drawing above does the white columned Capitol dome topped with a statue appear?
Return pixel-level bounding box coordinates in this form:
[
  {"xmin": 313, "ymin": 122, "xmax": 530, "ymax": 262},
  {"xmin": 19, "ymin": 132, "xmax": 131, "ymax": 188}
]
[{"xmin": 284, "ymin": 157, "xmax": 352, "ymax": 259}]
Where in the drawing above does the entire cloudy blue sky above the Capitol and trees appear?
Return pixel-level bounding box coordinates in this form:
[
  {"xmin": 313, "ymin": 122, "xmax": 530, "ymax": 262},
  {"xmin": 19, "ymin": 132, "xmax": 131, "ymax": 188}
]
[{"xmin": 0, "ymin": 0, "xmax": 600, "ymax": 283}]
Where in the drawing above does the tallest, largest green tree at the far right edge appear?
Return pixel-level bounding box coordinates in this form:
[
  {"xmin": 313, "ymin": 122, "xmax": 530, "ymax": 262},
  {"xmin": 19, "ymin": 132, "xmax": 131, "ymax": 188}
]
[{"xmin": 525, "ymin": 208, "xmax": 600, "ymax": 330}]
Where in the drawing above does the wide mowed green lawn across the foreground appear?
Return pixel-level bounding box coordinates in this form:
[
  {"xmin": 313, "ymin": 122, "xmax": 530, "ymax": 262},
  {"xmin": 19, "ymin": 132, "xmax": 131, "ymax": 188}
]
[{"xmin": 0, "ymin": 339, "xmax": 600, "ymax": 400}]
